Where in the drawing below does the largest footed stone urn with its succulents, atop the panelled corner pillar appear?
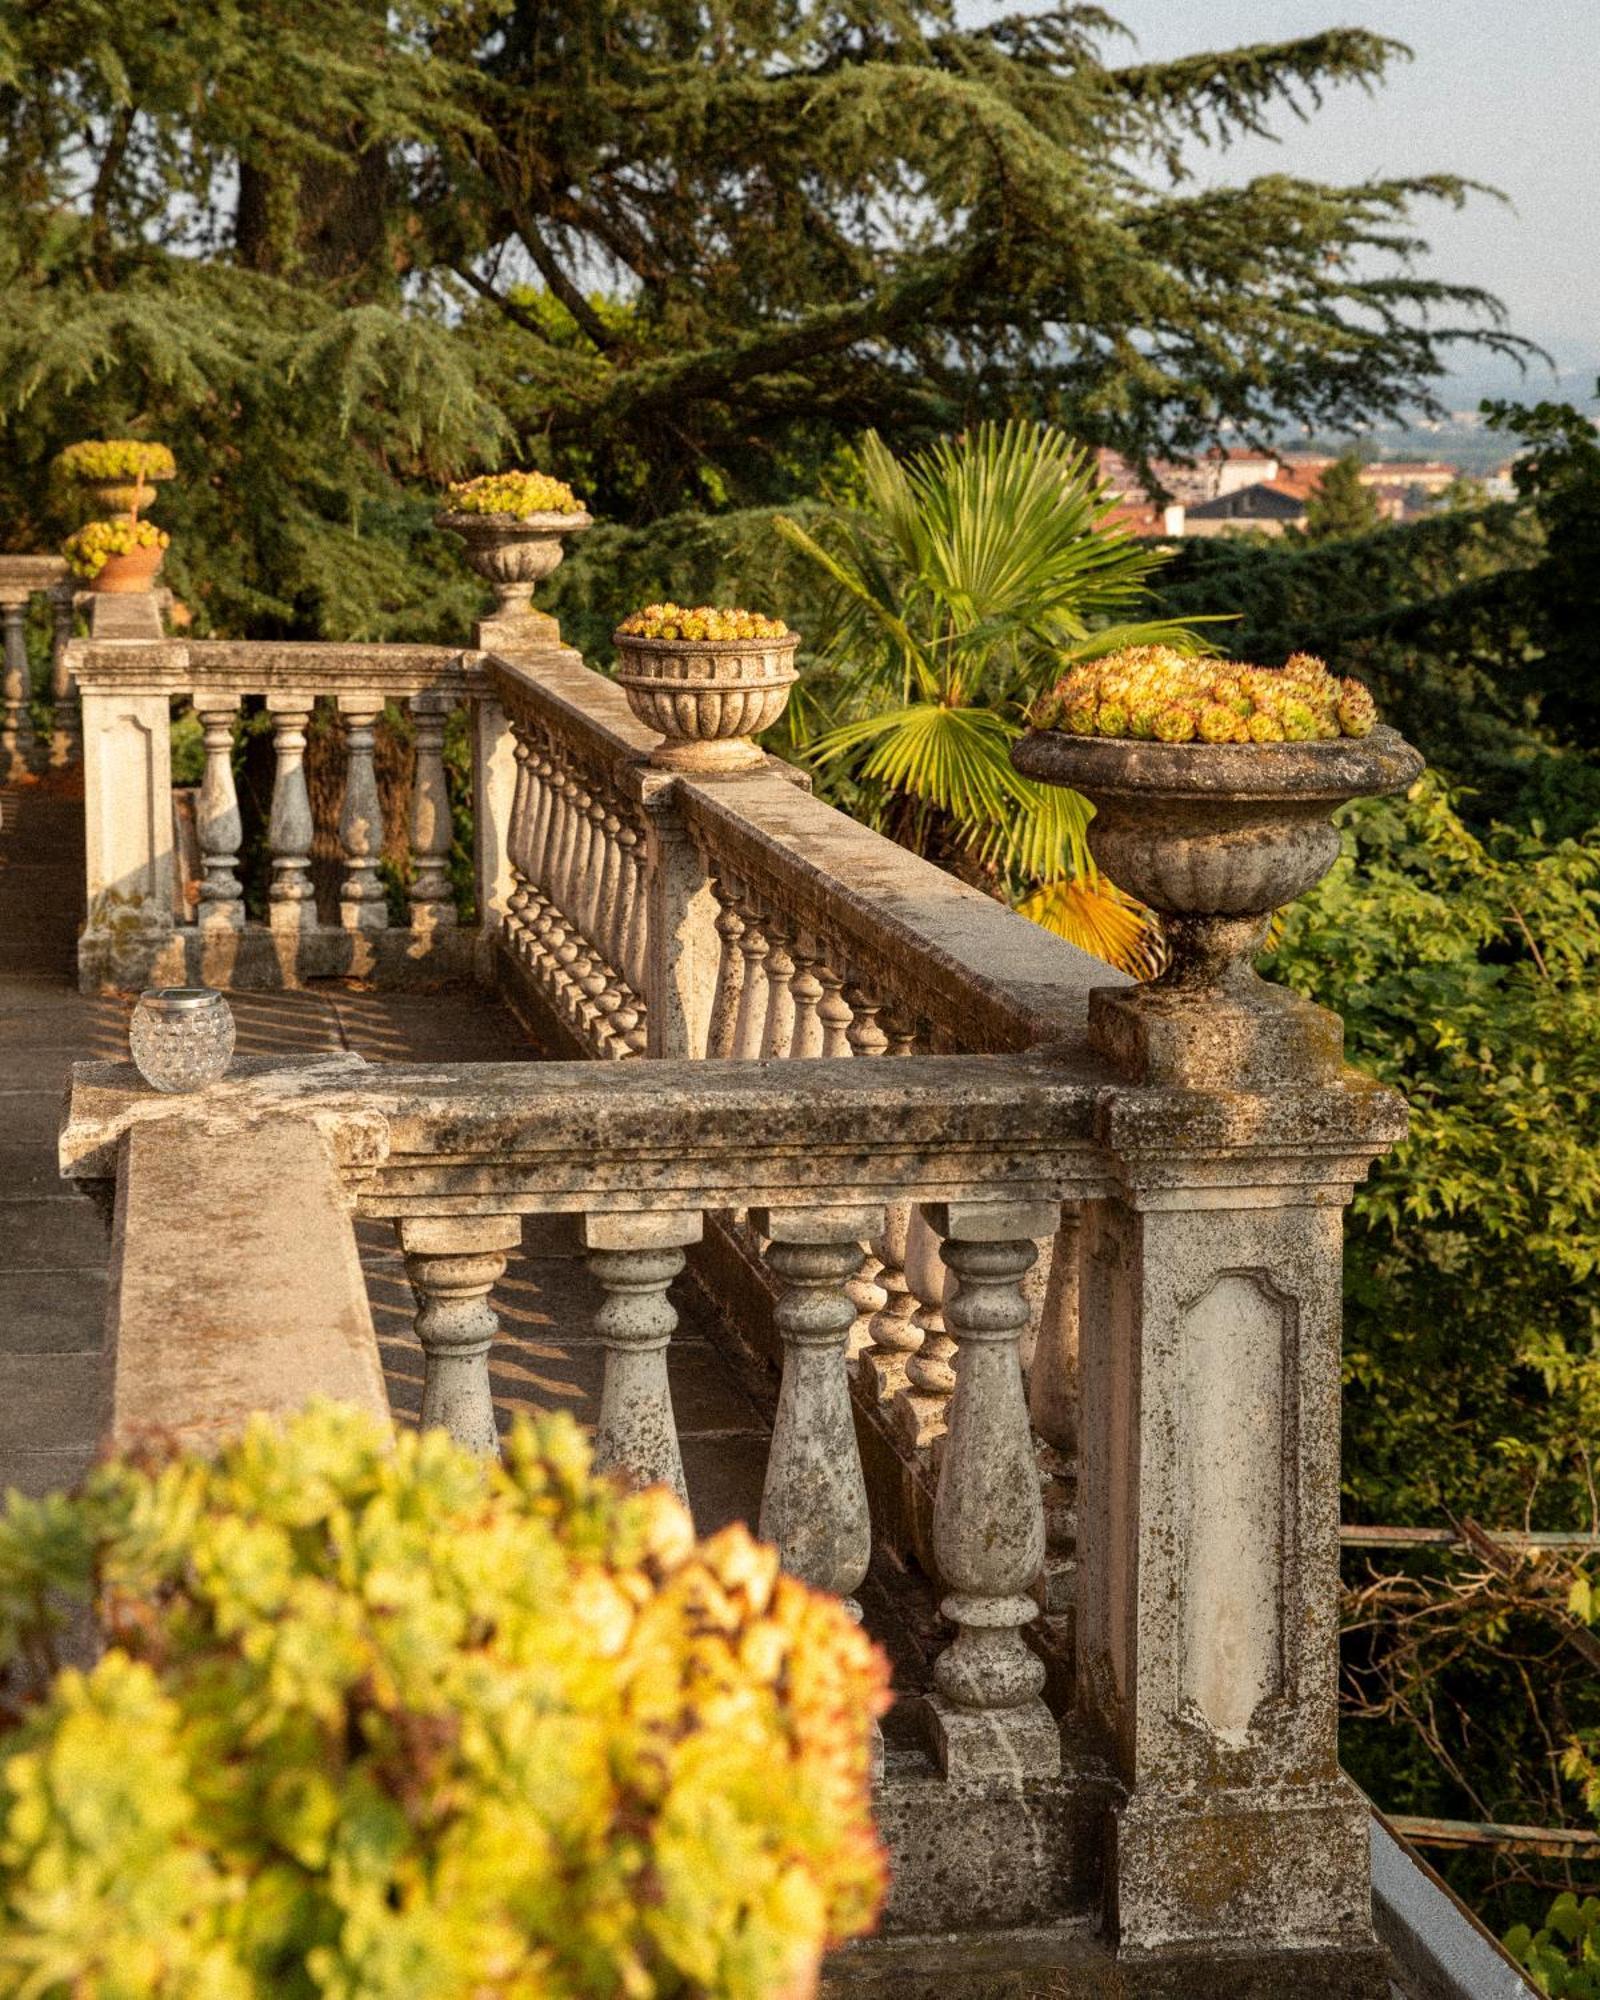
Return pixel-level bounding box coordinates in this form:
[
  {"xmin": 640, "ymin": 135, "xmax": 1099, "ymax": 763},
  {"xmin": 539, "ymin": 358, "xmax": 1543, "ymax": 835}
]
[{"xmin": 1012, "ymin": 646, "xmax": 1422, "ymax": 1088}]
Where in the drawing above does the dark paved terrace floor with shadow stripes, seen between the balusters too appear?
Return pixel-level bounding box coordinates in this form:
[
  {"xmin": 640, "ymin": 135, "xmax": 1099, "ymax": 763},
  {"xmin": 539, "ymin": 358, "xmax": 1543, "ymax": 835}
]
[{"xmin": 0, "ymin": 770, "xmax": 940, "ymax": 1704}]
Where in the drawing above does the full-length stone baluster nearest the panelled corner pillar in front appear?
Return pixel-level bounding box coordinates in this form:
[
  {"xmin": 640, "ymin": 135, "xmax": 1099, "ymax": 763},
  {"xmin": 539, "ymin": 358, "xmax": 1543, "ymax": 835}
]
[{"xmin": 928, "ymin": 1202, "xmax": 1060, "ymax": 1782}]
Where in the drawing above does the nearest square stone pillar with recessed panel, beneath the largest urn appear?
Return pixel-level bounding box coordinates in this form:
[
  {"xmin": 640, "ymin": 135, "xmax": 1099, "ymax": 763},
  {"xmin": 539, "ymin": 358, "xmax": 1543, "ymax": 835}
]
[{"xmin": 1078, "ymin": 1084, "xmax": 1404, "ymax": 1996}]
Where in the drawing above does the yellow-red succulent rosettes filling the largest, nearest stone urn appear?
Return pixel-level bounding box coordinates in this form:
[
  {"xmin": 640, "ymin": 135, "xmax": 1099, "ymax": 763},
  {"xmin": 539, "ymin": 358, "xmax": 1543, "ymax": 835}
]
[{"xmin": 1028, "ymin": 646, "xmax": 1378, "ymax": 744}]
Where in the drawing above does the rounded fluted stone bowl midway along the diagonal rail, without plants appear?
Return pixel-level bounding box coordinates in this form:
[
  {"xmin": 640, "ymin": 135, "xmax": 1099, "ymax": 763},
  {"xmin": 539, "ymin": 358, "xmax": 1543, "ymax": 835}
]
[{"xmin": 612, "ymin": 632, "xmax": 800, "ymax": 772}]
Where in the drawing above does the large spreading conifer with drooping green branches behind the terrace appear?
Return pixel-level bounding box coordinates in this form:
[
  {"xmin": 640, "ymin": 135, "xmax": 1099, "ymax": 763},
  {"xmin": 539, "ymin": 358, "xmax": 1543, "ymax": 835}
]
[{"xmin": 0, "ymin": 0, "xmax": 1508, "ymax": 636}]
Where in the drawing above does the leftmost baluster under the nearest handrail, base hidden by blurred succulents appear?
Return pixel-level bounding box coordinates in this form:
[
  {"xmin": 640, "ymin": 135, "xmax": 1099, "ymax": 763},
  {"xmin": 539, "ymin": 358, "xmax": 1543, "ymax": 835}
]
[{"xmin": 396, "ymin": 1216, "xmax": 522, "ymax": 1458}]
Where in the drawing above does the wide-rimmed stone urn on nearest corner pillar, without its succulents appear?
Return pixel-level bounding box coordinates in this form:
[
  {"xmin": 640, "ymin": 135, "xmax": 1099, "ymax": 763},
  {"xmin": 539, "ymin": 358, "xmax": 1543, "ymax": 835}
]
[{"xmin": 1012, "ymin": 726, "xmax": 1422, "ymax": 1088}]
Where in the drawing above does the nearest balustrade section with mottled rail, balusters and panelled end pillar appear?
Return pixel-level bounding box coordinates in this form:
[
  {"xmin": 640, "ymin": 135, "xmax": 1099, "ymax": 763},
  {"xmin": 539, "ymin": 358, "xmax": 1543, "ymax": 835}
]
[{"xmin": 62, "ymin": 1052, "xmax": 1404, "ymax": 1968}]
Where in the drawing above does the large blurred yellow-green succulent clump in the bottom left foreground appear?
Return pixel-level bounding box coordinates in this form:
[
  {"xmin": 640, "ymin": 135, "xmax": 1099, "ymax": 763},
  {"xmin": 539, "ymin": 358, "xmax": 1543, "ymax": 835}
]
[{"xmin": 0, "ymin": 1404, "xmax": 886, "ymax": 2000}]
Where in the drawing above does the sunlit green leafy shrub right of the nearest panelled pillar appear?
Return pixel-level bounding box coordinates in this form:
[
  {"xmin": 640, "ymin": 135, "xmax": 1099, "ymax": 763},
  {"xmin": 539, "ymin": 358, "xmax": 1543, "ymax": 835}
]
[{"xmin": 1270, "ymin": 780, "xmax": 1600, "ymax": 1528}]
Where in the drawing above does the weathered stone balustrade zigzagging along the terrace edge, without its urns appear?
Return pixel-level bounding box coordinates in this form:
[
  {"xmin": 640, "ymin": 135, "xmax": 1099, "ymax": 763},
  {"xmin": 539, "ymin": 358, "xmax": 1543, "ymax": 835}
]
[{"xmin": 62, "ymin": 580, "xmax": 1404, "ymax": 2000}]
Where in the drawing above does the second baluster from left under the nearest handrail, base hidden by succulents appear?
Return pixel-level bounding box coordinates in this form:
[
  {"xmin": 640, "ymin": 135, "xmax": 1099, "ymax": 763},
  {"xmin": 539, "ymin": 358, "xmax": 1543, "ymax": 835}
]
[{"xmin": 584, "ymin": 1212, "xmax": 702, "ymax": 1502}]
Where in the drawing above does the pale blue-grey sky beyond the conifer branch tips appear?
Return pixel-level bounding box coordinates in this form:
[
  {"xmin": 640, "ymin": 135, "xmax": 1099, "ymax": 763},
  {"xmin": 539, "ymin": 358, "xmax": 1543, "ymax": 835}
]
[{"xmin": 1024, "ymin": 0, "xmax": 1600, "ymax": 402}]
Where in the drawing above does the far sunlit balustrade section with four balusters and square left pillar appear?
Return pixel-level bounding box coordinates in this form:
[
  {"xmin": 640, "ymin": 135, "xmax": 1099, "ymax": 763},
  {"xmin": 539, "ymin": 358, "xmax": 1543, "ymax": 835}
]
[{"xmin": 64, "ymin": 596, "xmax": 494, "ymax": 990}]
